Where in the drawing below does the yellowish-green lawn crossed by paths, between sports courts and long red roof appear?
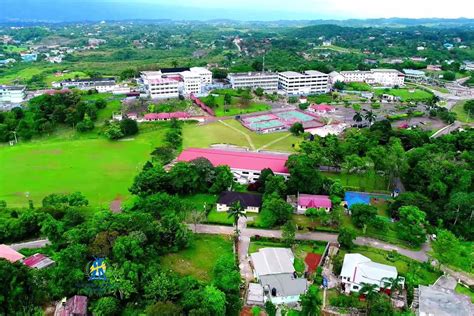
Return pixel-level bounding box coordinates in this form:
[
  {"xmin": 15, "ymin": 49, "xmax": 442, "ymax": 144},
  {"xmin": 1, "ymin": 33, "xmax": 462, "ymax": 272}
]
[{"xmin": 183, "ymin": 119, "xmax": 301, "ymax": 152}]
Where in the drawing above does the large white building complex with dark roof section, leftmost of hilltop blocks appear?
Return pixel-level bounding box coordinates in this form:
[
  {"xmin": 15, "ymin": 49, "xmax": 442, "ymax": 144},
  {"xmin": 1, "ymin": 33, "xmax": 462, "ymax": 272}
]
[{"xmin": 139, "ymin": 67, "xmax": 212, "ymax": 99}]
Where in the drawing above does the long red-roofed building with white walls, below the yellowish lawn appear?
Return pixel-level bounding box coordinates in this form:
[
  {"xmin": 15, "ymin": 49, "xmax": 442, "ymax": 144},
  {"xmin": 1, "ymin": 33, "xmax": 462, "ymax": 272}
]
[{"xmin": 178, "ymin": 148, "xmax": 289, "ymax": 184}]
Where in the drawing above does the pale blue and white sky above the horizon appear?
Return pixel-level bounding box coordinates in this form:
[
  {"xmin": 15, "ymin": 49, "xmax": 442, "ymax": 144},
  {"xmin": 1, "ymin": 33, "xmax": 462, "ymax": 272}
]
[{"xmin": 0, "ymin": 0, "xmax": 474, "ymax": 21}]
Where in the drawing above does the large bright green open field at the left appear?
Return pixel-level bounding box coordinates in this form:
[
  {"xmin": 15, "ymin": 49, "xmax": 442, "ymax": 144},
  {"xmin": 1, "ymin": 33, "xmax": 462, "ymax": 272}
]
[{"xmin": 0, "ymin": 127, "xmax": 166, "ymax": 206}]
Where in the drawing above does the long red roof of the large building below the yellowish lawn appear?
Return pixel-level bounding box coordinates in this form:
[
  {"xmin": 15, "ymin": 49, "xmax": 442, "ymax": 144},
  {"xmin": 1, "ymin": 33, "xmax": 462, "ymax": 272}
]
[{"xmin": 178, "ymin": 148, "xmax": 288, "ymax": 173}]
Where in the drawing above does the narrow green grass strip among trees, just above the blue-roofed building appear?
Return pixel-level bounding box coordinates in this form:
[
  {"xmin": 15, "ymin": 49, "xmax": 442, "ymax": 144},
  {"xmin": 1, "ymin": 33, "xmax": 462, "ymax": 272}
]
[{"xmin": 322, "ymin": 172, "xmax": 388, "ymax": 192}]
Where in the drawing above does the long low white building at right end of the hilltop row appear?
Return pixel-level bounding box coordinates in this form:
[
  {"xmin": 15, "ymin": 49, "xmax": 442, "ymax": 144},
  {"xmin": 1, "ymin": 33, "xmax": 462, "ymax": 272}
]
[{"xmin": 341, "ymin": 69, "xmax": 405, "ymax": 87}]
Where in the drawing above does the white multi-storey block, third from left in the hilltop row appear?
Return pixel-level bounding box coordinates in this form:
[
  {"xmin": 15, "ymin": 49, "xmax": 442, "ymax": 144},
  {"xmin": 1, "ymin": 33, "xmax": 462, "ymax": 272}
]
[{"xmin": 278, "ymin": 70, "xmax": 329, "ymax": 95}]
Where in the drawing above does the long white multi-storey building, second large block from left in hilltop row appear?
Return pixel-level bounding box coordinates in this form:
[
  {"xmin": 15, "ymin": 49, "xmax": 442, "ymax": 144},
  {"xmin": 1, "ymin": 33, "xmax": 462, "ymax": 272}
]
[{"xmin": 227, "ymin": 72, "xmax": 278, "ymax": 91}]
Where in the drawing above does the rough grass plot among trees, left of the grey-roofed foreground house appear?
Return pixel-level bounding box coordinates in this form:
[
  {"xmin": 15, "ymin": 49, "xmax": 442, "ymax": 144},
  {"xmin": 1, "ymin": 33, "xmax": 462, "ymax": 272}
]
[{"xmin": 161, "ymin": 235, "xmax": 232, "ymax": 282}]
